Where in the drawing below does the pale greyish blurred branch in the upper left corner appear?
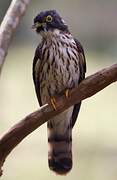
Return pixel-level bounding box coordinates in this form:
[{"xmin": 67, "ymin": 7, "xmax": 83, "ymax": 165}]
[{"xmin": 0, "ymin": 0, "xmax": 30, "ymax": 73}]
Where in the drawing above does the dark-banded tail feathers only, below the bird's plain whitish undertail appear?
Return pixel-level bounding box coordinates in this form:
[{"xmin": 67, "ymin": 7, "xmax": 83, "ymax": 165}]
[{"xmin": 48, "ymin": 118, "xmax": 72, "ymax": 175}]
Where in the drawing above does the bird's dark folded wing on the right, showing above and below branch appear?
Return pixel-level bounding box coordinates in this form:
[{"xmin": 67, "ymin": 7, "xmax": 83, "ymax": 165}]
[{"xmin": 71, "ymin": 39, "xmax": 86, "ymax": 127}]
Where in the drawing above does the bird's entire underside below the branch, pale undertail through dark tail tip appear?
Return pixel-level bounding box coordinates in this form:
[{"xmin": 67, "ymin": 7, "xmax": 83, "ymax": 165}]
[{"xmin": 47, "ymin": 107, "xmax": 73, "ymax": 175}]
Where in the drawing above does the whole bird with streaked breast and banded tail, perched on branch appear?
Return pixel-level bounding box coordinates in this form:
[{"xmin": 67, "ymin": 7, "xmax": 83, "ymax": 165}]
[{"xmin": 32, "ymin": 10, "xmax": 86, "ymax": 175}]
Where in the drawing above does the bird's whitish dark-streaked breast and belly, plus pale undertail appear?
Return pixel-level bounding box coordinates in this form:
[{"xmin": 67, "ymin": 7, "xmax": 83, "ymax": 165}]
[{"xmin": 40, "ymin": 30, "xmax": 79, "ymax": 134}]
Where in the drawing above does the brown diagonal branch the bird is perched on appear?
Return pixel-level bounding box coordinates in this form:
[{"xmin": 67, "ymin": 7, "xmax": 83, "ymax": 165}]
[{"xmin": 0, "ymin": 64, "xmax": 117, "ymax": 175}]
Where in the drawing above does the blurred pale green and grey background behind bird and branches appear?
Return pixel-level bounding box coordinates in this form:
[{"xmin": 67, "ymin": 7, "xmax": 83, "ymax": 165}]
[{"xmin": 0, "ymin": 0, "xmax": 117, "ymax": 180}]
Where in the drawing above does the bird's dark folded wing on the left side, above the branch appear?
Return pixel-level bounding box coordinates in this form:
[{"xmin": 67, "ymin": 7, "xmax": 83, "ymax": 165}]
[{"xmin": 33, "ymin": 46, "xmax": 42, "ymax": 106}]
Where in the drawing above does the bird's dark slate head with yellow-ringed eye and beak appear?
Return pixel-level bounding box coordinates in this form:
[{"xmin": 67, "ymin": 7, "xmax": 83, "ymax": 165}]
[{"xmin": 32, "ymin": 10, "xmax": 68, "ymax": 35}]
